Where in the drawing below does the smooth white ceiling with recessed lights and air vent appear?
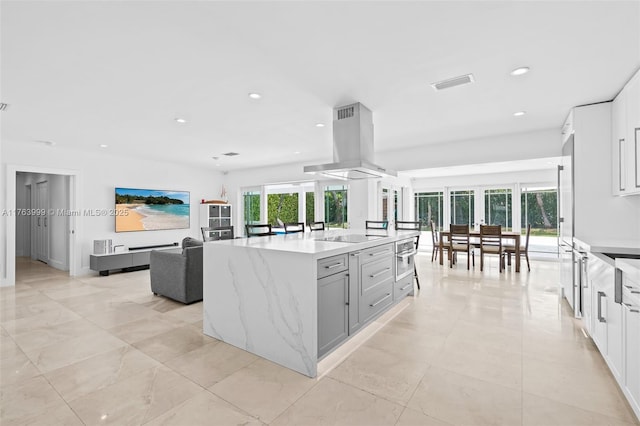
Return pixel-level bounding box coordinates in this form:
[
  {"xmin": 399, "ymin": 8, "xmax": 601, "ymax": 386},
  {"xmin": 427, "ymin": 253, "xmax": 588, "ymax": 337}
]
[{"xmin": 0, "ymin": 0, "xmax": 640, "ymax": 170}]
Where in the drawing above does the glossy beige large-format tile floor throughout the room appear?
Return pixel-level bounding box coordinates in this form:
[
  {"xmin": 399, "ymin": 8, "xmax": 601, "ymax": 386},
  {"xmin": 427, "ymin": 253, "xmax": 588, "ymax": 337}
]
[{"xmin": 0, "ymin": 255, "xmax": 640, "ymax": 426}]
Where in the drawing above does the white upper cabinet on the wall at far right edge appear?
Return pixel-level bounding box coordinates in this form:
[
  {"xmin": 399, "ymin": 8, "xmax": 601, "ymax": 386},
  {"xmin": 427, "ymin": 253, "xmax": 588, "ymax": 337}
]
[{"xmin": 611, "ymin": 71, "xmax": 640, "ymax": 195}]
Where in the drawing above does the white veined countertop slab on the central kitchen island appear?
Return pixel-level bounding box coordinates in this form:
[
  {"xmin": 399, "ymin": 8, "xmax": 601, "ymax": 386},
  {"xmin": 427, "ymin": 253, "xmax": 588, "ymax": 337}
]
[{"xmin": 205, "ymin": 229, "xmax": 419, "ymax": 258}]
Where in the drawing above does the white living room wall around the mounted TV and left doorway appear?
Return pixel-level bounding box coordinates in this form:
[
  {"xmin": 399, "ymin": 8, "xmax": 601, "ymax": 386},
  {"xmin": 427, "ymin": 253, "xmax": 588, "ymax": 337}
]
[{"xmin": 0, "ymin": 141, "xmax": 222, "ymax": 278}]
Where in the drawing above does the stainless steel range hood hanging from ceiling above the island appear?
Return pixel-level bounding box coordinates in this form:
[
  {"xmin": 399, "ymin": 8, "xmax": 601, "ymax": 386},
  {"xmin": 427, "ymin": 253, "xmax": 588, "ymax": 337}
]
[{"xmin": 304, "ymin": 103, "xmax": 398, "ymax": 179}]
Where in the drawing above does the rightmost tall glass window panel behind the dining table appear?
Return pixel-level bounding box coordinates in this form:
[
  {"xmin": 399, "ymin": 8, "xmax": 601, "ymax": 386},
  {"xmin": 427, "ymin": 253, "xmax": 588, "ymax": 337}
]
[{"xmin": 520, "ymin": 187, "xmax": 558, "ymax": 253}]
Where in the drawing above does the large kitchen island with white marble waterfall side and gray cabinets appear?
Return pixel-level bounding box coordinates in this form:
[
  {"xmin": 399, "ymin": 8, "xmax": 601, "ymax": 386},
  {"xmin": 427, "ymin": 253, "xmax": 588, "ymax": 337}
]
[{"xmin": 203, "ymin": 229, "xmax": 418, "ymax": 377}]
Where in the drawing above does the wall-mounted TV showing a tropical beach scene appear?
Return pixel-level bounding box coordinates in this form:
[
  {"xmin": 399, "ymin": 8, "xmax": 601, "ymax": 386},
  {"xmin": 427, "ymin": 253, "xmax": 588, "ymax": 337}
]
[{"xmin": 116, "ymin": 188, "xmax": 189, "ymax": 232}]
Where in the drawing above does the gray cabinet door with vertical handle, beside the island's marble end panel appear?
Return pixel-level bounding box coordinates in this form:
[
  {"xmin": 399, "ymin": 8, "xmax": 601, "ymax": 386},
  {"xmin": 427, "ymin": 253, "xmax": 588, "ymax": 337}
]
[{"xmin": 318, "ymin": 271, "xmax": 349, "ymax": 357}]
